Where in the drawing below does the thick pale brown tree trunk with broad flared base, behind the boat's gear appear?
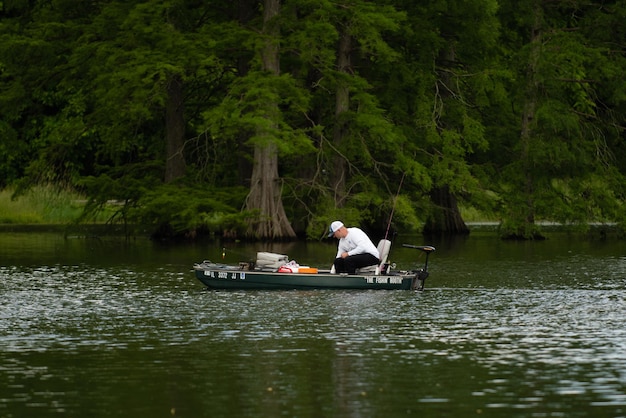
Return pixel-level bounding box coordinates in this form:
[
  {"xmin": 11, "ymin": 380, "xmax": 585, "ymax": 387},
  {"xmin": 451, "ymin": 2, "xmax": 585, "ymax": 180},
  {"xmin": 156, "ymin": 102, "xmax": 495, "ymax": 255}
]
[{"xmin": 241, "ymin": 0, "xmax": 296, "ymax": 239}]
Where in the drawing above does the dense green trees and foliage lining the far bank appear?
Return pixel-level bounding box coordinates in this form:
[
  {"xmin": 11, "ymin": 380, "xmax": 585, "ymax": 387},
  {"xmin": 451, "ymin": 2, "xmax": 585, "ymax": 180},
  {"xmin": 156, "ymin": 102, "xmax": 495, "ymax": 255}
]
[{"xmin": 0, "ymin": 0, "xmax": 626, "ymax": 239}]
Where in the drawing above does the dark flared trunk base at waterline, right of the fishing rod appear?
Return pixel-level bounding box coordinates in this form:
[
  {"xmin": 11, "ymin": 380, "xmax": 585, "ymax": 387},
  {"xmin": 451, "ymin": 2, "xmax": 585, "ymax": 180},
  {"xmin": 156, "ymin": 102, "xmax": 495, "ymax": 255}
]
[{"xmin": 424, "ymin": 186, "xmax": 470, "ymax": 235}]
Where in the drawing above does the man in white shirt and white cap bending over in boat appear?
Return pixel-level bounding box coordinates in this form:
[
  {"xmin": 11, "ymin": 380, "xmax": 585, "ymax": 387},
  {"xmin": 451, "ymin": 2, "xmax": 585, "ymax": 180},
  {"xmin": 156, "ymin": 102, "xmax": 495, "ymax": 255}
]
[{"xmin": 328, "ymin": 221, "xmax": 380, "ymax": 274}]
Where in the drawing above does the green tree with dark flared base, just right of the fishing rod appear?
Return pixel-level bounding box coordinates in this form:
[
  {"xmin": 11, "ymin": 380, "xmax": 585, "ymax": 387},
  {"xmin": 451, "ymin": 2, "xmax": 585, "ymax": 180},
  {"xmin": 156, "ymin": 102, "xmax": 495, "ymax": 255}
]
[{"xmin": 378, "ymin": 0, "xmax": 499, "ymax": 233}]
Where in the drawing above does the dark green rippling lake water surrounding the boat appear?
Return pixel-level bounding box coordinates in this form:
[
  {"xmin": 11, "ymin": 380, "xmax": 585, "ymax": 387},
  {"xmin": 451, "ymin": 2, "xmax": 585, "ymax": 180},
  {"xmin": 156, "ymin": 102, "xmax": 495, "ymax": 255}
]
[{"xmin": 0, "ymin": 232, "xmax": 626, "ymax": 418}]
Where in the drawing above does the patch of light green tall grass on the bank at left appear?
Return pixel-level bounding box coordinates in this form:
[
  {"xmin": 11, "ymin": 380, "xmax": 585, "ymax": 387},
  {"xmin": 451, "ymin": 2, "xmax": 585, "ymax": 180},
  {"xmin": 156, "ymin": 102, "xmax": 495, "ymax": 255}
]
[{"xmin": 0, "ymin": 186, "xmax": 85, "ymax": 225}]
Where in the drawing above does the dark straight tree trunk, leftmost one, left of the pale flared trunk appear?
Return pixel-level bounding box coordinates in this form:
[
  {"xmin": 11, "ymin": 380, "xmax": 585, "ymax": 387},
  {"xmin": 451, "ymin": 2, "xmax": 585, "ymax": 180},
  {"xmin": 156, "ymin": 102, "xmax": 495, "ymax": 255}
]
[{"xmin": 165, "ymin": 75, "xmax": 185, "ymax": 183}]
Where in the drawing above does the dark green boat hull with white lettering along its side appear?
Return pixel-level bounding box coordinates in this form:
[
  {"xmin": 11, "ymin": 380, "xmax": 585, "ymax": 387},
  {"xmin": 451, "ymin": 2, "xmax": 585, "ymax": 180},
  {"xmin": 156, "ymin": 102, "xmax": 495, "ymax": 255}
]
[{"xmin": 194, "ymin": 265, "xmax": 425, "ymax": 290}]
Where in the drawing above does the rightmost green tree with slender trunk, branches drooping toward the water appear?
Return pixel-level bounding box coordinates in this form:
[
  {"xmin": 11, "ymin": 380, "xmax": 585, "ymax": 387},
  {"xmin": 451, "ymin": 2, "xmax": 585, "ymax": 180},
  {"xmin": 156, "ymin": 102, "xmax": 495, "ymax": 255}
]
[{"xmin": 492, "ymin": 1, "xmax": 623, "ymax": 238}]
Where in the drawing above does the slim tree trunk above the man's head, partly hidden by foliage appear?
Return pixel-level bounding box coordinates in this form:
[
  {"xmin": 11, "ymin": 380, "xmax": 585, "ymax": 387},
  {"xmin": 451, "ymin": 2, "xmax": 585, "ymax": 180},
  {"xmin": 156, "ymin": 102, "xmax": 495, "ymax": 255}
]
[{"xmin": 331, "ymin": 31, "xmax": 352, "ymax": 207}]
